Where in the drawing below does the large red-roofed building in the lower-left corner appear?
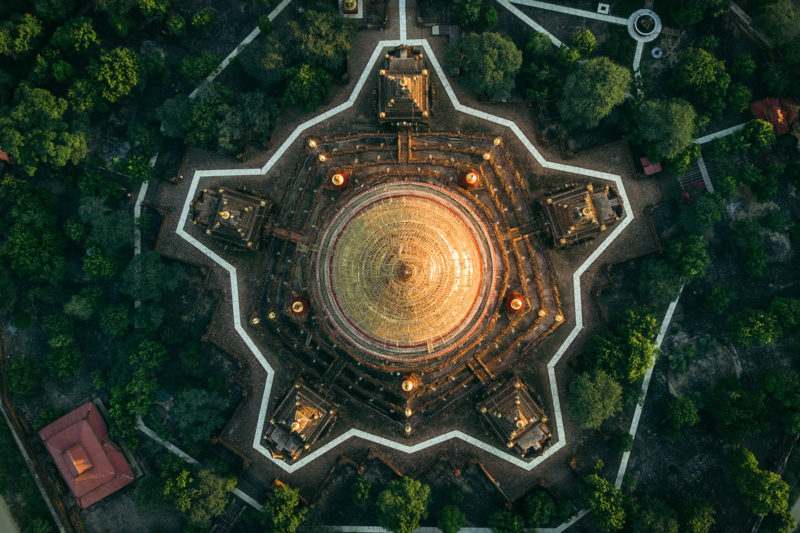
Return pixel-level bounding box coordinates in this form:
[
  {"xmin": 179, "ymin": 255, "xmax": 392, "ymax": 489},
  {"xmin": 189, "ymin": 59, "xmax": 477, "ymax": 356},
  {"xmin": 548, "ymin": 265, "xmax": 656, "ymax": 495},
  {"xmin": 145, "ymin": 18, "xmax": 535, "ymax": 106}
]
[{"xmin": 39, "ymin": 402, "xmax": 134, "ymax": 509}]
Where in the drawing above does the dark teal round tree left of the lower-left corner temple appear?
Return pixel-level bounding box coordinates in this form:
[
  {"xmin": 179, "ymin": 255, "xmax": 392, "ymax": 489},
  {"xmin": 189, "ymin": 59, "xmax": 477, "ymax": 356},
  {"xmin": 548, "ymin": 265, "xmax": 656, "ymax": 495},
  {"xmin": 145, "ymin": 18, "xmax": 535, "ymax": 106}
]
[{"xmin": 174, "ymin": 389, "xmax": 228, "ymax": 443}]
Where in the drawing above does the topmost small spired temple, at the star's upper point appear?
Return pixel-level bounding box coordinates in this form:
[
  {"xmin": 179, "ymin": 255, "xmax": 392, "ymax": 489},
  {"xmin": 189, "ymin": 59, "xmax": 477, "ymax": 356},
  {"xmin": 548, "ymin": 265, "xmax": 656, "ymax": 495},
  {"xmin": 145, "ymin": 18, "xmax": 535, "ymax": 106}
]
[{"xmin": 378, "ymin": 45, "xmax": 432, "ymax": 127}]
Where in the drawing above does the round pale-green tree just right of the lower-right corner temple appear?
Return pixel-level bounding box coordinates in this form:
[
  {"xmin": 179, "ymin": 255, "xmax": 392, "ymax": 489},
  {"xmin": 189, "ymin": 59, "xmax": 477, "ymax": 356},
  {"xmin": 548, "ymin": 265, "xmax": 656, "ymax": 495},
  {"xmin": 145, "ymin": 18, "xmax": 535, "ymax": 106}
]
[{"xmin": 568, "ymin": 370, "xmax": 622, "ymax": 429}]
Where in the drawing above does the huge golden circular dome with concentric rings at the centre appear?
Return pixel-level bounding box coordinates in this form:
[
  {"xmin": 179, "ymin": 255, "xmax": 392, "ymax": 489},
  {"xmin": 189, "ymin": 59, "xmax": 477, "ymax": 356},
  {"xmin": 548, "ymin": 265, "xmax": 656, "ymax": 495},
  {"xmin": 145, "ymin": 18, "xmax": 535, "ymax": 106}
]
[{"xmin": 315, "ymin": 182, "xmax": 495, "ymax": 363}]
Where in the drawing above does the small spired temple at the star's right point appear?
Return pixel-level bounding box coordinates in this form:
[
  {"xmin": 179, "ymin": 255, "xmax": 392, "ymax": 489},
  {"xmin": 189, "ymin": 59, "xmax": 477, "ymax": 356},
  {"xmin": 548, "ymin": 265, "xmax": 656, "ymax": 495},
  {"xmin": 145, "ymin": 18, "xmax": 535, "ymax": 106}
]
[{"xmin": 542, "ymin": 183, "xmax": 623, "ymax": 248}]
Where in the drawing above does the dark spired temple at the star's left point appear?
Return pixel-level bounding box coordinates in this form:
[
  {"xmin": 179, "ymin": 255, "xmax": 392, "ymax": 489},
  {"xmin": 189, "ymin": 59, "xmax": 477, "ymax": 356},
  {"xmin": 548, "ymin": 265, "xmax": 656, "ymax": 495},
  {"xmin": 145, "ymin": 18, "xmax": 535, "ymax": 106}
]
[{"xmin": 191, "ymin": 188, "xmax": 270, "ymax": 250}]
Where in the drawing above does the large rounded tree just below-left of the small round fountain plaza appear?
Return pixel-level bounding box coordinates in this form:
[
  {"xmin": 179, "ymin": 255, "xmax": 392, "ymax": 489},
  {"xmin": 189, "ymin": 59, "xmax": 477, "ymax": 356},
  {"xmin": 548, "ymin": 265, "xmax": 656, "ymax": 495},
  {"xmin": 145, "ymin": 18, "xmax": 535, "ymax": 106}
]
[{"xmin": 558, "ymin": 57, "xmax": 631, "ymax": 128}]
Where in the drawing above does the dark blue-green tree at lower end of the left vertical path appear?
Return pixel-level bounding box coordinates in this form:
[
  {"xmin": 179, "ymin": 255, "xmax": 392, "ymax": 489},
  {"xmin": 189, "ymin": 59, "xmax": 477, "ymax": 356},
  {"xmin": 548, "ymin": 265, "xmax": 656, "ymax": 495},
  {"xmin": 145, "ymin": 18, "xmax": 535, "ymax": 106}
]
[{"xmin": 120, "ymin": 251, "xmax": 183, "ymax": 302}]
